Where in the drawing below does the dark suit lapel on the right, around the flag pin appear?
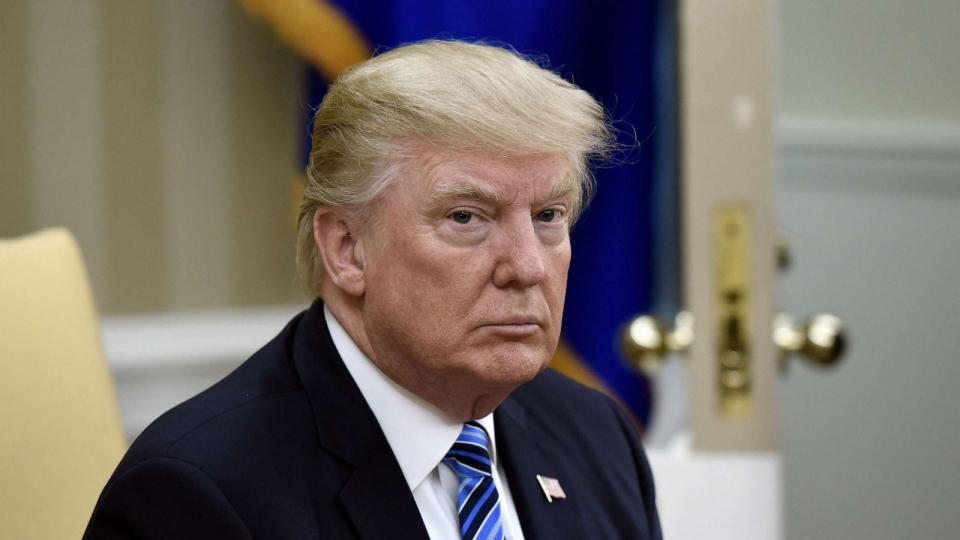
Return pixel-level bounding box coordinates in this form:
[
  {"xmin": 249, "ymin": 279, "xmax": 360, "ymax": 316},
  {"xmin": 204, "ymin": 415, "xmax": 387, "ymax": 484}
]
[{"xmin": 495, "ymin": 396, "xmax": 588, "ymax": 538}]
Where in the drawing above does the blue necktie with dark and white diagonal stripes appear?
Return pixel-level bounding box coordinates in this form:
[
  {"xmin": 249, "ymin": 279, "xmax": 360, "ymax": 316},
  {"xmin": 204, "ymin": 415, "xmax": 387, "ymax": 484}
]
[{"xmin": 443, "ymin": 422, "xmax": 504, "ymax": 540}]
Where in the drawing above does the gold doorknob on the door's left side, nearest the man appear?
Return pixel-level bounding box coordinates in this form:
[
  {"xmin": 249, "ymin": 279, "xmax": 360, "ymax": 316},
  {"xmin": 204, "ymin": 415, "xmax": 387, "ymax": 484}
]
[{"xmin": 620, "ymin": 311, "xmax": 693, "ymax": 374}]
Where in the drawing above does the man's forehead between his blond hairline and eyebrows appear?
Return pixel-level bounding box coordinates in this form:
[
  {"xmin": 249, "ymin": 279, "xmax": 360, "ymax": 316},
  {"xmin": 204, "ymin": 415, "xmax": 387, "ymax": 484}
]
[{"xmin": 401, "ymin": 148, "xmax": 576, "ymax": 200}]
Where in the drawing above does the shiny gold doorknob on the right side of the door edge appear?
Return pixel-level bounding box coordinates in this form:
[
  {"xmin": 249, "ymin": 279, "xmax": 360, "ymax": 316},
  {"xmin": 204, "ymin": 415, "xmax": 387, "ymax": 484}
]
[{"xmin": 773, "ymin": 313, "xmax": 847, "ymax": 369}]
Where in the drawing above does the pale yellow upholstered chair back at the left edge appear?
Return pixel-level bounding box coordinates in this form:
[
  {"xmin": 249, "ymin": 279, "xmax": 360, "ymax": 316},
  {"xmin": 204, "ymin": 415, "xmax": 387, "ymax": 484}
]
[{"xmin": 0, "ymin": 229, "xmax": 126, "ymax": 539}]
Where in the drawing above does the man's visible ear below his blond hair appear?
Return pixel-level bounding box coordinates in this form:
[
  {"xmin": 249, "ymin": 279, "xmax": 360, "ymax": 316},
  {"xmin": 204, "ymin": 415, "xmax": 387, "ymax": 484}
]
[{"xmin": 313, "ymin": 208, "xmax": 365, "ymax": 296}]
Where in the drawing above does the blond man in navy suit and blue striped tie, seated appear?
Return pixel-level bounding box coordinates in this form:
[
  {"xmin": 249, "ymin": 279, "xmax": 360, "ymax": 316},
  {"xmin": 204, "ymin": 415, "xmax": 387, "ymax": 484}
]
[{"xmin": 86, "ymin": 41, "xmax": 660, "ymax": 539}]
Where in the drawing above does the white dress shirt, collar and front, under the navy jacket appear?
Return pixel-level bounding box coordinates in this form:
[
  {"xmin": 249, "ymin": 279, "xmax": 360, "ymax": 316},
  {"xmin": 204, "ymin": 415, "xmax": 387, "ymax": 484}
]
[{"xmin": 323, "ymin": 306, "xmax": 523, "ymax": 540}]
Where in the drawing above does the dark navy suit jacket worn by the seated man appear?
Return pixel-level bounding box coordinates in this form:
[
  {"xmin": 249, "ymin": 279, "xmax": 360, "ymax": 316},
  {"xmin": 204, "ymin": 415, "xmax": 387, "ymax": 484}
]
[{"xmin": 84, "ymin": 301, "xmax": 661, "ymax": 540}]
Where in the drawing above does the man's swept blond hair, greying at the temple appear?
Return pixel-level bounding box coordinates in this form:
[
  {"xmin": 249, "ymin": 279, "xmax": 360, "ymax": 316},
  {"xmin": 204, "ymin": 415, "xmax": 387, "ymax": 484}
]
[{"xmin": 297, "ymin": 40, "xmax": 613, "ymax": 296}]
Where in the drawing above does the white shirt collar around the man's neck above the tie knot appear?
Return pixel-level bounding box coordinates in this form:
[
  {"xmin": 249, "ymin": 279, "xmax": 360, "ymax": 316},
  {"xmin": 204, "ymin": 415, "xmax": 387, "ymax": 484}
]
[{"xmin": 323, "ymin": 306, "xmax": 497, "ymax": 491}]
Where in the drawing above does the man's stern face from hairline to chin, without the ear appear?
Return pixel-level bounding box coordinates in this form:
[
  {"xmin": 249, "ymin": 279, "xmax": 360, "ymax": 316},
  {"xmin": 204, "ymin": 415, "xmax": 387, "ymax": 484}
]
[{"xmin": 361, "ymin": 149, "xmax": 575, "ymax": 419}]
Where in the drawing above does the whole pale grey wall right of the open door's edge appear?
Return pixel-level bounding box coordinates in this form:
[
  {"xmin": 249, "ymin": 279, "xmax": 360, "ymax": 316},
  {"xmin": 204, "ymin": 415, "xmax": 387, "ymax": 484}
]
[{"xmin": 777, "ymin": 0, "xmax": 960, "ymax": 540}]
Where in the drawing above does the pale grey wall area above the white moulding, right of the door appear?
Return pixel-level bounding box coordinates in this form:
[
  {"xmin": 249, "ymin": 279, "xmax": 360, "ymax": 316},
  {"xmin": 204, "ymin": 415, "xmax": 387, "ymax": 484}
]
[{"xmin": 779, "ymin": 0, "xmax": 960, "ymax": 123}]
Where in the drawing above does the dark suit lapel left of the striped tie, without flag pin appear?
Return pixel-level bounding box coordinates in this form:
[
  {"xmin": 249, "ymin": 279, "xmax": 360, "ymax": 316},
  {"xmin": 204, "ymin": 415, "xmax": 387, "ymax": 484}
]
[{"xmin": 293, "ymin": 301, "xmax": 428, "ymax": 540}]
